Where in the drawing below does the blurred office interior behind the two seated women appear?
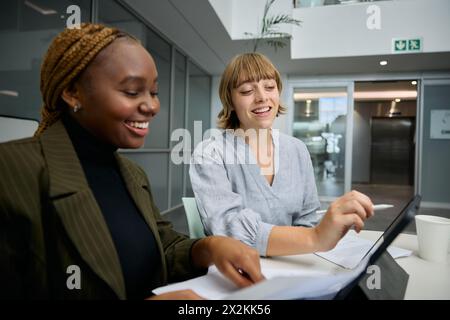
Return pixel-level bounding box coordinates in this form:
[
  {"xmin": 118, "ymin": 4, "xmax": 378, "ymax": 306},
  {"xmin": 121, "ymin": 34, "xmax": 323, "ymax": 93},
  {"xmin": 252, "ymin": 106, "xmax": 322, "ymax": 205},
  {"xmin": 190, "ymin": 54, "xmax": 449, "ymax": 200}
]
[{"xmin": 0, "ymin": 0, "xmax": 450, "ymax": 232}]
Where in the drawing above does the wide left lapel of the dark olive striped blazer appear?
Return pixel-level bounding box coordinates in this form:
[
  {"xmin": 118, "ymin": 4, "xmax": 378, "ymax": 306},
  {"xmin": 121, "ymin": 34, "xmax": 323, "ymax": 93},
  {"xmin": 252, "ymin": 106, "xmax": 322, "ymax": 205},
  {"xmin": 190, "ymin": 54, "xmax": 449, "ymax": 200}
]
[{"xmin": 41, "ymin": 121, "xmax": 126, "ymax": 299}]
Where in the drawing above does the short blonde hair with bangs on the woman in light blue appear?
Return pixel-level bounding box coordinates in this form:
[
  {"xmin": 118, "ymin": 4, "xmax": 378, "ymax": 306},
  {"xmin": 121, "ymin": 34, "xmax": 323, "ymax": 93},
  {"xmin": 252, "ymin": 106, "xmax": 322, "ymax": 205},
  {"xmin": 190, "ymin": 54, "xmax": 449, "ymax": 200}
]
[{"xmin": 217, "ymin": 53, "xmax": 286, "ymax": 129}]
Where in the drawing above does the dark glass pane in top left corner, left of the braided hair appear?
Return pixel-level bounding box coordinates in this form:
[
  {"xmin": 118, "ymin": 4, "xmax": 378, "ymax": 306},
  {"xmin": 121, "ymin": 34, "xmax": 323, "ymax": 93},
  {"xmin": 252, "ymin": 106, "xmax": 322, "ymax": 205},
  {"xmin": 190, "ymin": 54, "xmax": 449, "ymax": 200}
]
[{"xmin": 0, "ymin": 0, "xmax": 91, "ymax": 120}]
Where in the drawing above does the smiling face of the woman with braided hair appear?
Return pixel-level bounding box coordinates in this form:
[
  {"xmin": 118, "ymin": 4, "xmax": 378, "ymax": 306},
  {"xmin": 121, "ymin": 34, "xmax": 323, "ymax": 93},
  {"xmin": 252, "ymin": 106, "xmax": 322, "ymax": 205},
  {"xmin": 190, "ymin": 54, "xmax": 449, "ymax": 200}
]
[{"xmin": 63, "ymin": 38, "xmax": 160, "ymax": 148}]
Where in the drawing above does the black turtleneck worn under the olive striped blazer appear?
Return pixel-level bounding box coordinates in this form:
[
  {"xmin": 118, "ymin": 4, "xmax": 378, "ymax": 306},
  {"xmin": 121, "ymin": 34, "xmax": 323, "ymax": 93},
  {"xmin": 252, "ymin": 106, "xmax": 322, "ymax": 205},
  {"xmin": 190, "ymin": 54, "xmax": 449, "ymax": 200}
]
[{"xmin": 63, "ymin": 115, "xmax": 160, "ymax": 299}]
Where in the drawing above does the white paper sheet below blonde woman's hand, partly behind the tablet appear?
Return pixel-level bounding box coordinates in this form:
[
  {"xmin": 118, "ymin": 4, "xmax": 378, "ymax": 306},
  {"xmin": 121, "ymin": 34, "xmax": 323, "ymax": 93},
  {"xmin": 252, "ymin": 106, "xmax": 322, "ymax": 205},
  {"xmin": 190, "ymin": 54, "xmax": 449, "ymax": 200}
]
[{"xmin": 316, "ymin": 232, "xmax": 412, "ymax": 269}]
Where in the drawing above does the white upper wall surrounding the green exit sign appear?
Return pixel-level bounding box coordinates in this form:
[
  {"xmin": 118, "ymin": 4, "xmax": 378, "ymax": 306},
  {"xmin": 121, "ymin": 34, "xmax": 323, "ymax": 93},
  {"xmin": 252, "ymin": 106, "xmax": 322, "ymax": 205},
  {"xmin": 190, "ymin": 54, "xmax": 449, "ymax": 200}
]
[{"xmin": 291, "ymin": 0, "xmax": 450, "ymax": 59}]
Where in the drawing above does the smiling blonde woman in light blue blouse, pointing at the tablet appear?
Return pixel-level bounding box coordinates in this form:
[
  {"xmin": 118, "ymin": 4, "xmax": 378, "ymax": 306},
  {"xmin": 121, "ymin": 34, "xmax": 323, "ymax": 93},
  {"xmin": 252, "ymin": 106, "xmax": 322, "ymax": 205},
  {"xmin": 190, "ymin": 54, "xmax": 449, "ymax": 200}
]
[{"xmin": 189, "ymin": 53, "xmax": 373, "ymax": 256}]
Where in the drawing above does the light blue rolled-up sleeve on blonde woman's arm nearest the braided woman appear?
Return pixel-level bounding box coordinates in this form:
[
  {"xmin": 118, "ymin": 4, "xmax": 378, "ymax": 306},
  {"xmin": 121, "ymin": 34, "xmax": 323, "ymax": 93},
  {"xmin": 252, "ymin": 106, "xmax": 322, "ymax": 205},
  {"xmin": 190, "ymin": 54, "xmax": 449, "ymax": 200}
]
[{"xmin": 189, "ymin": 146, "xmax": 273, "ymax": 256}]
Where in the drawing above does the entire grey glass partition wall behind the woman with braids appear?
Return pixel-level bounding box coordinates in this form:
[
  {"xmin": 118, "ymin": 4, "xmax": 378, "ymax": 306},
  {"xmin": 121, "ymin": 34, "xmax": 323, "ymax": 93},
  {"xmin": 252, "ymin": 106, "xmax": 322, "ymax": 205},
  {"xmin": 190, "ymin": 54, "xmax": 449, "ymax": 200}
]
[{"xmin": 0, "ymin": 0, "xmax": 211, "ymax": 212}]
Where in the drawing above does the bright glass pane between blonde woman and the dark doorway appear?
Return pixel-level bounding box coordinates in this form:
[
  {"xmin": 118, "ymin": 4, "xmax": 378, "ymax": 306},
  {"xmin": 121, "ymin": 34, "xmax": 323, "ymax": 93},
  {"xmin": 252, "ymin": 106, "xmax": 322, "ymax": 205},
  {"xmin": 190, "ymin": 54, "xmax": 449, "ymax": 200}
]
[{"xmin": 293, "ymin": 87, "xmax": 348, "ymax": 197}]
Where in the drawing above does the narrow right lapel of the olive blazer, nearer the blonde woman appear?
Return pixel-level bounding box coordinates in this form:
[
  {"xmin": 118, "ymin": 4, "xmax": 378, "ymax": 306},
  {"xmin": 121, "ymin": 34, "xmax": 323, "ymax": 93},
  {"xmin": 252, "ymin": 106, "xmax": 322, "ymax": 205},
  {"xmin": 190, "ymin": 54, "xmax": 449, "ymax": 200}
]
[{"xmin": 116, "ymin": 154, "xmax": 167, "ymax": 283}]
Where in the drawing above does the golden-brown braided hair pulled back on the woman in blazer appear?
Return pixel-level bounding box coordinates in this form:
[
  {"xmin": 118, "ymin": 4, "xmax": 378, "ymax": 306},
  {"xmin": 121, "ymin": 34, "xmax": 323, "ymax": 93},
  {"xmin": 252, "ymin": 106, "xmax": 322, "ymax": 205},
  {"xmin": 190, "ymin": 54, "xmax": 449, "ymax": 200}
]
[{"xmin": 34, "ymin": 23, "xmax": 139, "ymax": 136}]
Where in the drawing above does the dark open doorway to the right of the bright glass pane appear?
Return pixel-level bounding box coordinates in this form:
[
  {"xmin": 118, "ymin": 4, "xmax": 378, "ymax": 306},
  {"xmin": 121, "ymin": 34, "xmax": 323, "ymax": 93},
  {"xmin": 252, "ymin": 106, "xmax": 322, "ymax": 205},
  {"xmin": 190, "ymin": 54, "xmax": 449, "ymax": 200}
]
[{"xmin": 352, "ymin": 79, "xmax": 417, "ymax": 228}]
